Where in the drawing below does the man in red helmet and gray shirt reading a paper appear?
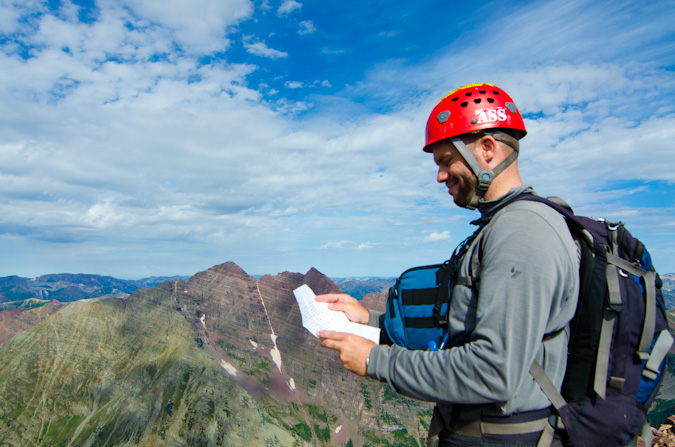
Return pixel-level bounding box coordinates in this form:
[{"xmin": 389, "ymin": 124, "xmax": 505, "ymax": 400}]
[{"xmin": 317, "ymin": 84, "xmax": 579, "ymax": 446}]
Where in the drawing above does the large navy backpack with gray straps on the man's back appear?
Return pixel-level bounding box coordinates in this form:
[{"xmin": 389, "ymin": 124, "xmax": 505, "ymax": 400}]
[{"xmin": 519, "ymin": 195, "xmax": 673, "ymax": 447}]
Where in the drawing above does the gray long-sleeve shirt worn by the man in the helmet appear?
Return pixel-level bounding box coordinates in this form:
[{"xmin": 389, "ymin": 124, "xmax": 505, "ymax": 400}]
[{"xmin": 368, "ymin": 186, "xmax": 579, "ymax": 421}]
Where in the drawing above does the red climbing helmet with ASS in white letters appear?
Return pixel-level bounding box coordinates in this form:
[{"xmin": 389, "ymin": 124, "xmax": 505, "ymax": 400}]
[{"xmin": 424, "ymin": 84, "xmax": 527, "ymax": 152}]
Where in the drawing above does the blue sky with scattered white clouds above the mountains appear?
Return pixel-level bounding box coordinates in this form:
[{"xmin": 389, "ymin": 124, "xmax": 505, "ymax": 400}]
[{"xmin": 0, "ymin": 0, "xmax": 675, "ymax": 278}]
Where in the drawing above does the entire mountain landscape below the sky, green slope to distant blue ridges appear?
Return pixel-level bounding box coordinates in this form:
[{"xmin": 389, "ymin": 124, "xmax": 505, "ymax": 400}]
[{"xmin": 0, "ymin": 262, "xmax": 675, "ymax": 447}]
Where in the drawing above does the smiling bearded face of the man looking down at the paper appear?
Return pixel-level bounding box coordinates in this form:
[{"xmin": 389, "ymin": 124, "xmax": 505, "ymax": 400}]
[{"xmin": 432, "ymin": 140, "xmax": 478, "ymax": 208}]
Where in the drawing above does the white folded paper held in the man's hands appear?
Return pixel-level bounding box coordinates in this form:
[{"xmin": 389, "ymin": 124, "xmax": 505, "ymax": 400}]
[{"xmin": 293, "ymin": 284, "xmax": 380, "ymax": 344}]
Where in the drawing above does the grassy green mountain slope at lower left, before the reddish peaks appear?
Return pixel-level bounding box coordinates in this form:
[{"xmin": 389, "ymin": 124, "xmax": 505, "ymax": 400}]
[{"xmin": 0, "ymin": 284, "xmax": 295, "ymax": 447}]
